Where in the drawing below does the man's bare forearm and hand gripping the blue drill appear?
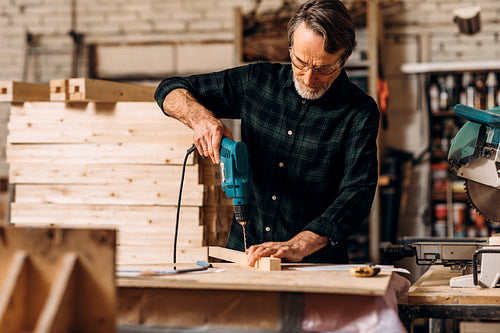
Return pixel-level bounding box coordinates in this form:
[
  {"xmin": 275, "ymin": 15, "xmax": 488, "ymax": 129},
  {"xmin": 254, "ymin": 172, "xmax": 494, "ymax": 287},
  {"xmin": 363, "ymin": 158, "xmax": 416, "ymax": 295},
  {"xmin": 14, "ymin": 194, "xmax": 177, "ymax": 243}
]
[{"xmin": 163, "ymin": 89, "xmax": 233, "ymax": 164}]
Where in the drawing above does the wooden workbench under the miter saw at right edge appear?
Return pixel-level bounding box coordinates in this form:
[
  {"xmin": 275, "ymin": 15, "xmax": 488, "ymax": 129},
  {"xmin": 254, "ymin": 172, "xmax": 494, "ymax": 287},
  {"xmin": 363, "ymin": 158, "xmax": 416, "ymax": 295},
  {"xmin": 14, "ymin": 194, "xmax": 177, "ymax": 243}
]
[{"xmin": 398, "ymin": 265, "xmax": 500, "ymax": 332}]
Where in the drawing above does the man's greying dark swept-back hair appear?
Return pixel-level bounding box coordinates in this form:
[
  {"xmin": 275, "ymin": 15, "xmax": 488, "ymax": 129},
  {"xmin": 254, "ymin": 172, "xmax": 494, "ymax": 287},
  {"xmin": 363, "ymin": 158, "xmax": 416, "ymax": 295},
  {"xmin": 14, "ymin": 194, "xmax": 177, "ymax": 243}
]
[{"xmin": 288, "ymin": 0, "xmax": 356, "ymax": 64}]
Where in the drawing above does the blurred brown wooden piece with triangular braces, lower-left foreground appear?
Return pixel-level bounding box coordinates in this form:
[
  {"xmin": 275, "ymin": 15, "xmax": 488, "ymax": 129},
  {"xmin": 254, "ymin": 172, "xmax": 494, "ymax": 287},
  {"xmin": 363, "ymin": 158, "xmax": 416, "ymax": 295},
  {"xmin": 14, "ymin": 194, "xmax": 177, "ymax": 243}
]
[{"xmin": 0, "ymin": 226, "xmax": 116, "ymax": 333}]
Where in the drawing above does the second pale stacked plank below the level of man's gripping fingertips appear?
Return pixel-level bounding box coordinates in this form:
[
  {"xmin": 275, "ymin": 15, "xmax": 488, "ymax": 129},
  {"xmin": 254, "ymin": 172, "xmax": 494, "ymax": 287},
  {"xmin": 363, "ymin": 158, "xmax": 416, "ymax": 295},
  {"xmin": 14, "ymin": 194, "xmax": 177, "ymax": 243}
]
[{"xmin": 15, "ymin": 184, "xmax": 203, "ymax": 206}]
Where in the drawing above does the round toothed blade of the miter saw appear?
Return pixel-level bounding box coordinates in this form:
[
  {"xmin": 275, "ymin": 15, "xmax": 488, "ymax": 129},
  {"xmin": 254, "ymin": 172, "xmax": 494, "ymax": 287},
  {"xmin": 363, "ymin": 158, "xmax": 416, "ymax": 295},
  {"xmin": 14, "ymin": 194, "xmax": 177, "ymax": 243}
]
[{"xmin": 465, "ymin": 179, "xmax": 500, "ymax": 222}]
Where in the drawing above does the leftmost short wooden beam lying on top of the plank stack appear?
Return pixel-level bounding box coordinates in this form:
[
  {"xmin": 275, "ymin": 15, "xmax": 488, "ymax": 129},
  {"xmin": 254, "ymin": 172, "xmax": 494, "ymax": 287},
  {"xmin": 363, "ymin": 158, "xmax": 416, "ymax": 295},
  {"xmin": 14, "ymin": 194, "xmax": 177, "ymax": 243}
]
[{"xmin": 0, "ymin": 81, "xmax": 50, "ymax": 102}]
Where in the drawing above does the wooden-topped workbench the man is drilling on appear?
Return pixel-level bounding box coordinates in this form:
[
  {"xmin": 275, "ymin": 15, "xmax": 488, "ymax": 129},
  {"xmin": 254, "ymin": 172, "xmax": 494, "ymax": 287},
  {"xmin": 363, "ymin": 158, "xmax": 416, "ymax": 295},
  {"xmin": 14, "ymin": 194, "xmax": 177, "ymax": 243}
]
[{"xmin": 117, "ymin": 263, "xmax": 410, "ymax": 333}]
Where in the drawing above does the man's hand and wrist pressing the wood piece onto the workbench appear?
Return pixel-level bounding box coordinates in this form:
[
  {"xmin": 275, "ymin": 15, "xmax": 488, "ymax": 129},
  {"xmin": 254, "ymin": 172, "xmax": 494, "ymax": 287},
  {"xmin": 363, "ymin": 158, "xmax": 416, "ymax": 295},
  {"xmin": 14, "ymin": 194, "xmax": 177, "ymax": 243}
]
[{"xmin": 246, "ymin": 231, "xmax": 328, "ymax": 267}]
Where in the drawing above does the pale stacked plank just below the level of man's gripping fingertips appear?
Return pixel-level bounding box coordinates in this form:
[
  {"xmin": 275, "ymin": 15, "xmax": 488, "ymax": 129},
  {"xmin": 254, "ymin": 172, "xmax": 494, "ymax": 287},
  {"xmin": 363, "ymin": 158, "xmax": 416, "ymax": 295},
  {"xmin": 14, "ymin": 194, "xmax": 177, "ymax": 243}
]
[{"xmin": 9, "ymin": 163, "xmax": 199, "ymax": 188}]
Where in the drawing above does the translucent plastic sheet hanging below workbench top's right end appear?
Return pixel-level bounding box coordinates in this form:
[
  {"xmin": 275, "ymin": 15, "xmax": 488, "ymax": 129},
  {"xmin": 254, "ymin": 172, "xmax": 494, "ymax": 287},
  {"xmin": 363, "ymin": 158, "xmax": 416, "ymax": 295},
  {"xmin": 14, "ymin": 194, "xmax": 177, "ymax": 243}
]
[{"xmin": 302, "ymin": 274, "xmax": 410, "ymax": 333}]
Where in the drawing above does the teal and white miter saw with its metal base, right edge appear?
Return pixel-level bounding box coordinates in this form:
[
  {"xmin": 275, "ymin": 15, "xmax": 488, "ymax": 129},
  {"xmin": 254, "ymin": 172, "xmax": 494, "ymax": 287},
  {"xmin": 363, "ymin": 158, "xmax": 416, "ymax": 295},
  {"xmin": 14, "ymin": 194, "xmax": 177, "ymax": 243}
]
[{"xmin": 385, "ymin": 104, "xmax": 500, "ymax": 288}]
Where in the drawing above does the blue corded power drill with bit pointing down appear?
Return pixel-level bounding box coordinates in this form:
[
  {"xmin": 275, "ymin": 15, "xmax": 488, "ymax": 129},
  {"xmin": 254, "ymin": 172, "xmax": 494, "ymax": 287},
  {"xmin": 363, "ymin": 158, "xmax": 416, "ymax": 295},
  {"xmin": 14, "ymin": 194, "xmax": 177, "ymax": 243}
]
[{"xmin": 220, "ymin": 138, "xmax": 249, "ymax": 250}]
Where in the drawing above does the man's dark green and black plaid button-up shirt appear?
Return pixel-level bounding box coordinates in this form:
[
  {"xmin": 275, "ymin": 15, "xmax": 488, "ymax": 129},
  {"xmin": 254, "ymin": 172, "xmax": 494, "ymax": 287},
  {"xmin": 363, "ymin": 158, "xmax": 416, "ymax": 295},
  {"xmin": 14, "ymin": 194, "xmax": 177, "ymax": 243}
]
[{"xmin": 155, "ymin": 63, "xmax": 379, "ymax": 262}]
